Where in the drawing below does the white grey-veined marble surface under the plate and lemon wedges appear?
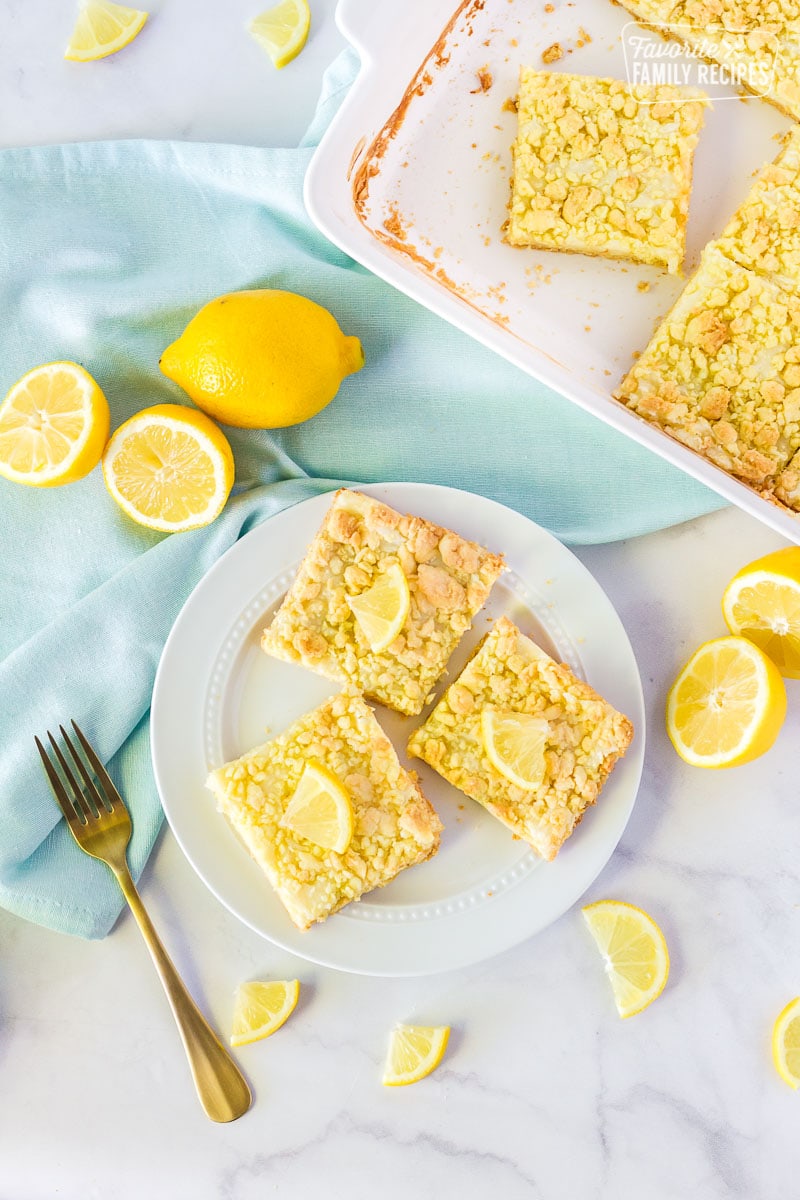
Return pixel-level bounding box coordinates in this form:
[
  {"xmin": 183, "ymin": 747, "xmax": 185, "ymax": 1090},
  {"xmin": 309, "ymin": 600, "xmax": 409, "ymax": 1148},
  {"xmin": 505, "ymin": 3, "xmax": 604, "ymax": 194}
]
[{"xmin": 0, "ymin": 0, "xmax": 800, "ymax": 1200}]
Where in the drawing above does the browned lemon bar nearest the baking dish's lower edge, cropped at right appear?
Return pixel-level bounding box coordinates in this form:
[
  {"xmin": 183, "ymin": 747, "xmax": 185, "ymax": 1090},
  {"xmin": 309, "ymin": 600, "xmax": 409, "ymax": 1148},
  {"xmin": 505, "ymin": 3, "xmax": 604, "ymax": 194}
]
[{"xmin": 616, "ymin": 244, "xmax": 800, "ymax": 501}]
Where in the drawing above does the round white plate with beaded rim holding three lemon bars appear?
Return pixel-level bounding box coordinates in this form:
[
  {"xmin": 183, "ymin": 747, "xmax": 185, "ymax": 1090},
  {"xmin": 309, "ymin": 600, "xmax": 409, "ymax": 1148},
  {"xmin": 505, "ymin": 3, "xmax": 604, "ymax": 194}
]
[{"xmin": 151, "ymin": 484, "xmax": 644, "ymax": 976}]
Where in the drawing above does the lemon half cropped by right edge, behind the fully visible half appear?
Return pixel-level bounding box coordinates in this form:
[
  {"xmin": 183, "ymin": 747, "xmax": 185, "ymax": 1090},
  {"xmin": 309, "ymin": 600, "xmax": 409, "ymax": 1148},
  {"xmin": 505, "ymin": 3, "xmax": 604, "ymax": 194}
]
[{"xmin": 722, "ymin": 546, "xmax": 800, "ymax": 679}]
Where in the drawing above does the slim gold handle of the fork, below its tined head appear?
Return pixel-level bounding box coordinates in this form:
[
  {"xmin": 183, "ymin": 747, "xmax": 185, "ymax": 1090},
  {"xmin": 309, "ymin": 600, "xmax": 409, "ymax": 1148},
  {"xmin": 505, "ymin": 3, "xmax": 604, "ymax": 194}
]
[{"xmin": 113, "ymin": 865, "xmax": 252, "ymax": 1121}]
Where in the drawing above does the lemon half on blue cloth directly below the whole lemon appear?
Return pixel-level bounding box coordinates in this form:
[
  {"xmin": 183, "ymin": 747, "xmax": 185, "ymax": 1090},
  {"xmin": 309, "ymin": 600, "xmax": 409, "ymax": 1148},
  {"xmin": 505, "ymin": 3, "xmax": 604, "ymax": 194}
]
[{"xmin": 103, "ymin": 404, "xmax": 234, "ymax": 533}]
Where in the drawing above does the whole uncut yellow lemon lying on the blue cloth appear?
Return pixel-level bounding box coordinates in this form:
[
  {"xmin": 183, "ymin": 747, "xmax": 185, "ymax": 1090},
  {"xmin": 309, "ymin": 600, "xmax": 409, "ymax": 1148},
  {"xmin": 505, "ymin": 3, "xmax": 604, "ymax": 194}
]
[{"xmin": 160, "ymin": 288, "xmax": 363, "ymax": 430}]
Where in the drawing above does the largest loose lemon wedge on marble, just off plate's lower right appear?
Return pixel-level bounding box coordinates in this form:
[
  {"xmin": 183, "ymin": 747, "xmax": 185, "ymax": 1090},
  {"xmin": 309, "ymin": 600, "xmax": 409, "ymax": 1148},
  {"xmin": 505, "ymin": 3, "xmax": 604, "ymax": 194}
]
[{"xmin": 582, "ymin": 900, "xmax": 669, "ymax": 1016}]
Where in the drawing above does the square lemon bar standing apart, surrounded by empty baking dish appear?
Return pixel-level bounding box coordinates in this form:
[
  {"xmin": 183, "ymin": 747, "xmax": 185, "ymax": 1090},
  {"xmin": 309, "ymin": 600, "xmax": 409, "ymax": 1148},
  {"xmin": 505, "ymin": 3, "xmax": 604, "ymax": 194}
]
[{"xmin": 506, "ymin": 67, "xmax": 706, "ymax": 274}]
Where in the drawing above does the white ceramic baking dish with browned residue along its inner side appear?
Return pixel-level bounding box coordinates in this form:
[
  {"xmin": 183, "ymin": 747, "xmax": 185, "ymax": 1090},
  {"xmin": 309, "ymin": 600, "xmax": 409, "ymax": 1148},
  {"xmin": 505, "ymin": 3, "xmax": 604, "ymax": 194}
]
[{"xmin": 305, "ymin": 0, "xmax": 800, "ymax": 542}]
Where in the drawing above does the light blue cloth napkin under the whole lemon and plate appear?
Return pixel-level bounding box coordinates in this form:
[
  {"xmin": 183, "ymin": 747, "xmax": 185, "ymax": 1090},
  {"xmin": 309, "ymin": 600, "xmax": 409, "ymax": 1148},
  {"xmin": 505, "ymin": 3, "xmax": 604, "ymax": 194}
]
[{"xmin": 0, "ymin": 52, "xmax": 721, "ymax": 937}]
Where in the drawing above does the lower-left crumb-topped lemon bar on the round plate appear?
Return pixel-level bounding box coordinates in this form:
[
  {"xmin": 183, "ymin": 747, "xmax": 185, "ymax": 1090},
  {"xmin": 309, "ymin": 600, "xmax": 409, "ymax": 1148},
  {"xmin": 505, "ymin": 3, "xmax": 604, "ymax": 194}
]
[{"xmin": 207, "ymin": 692, "xmax": 441, "ymax": 929}]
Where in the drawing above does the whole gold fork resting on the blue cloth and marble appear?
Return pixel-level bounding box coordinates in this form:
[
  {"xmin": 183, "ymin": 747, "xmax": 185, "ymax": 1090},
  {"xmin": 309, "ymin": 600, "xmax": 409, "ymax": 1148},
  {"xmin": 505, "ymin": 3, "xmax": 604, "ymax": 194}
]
[{"xmin": 36, "ymin": 721, "xmax": 252, "ymax": 1121}]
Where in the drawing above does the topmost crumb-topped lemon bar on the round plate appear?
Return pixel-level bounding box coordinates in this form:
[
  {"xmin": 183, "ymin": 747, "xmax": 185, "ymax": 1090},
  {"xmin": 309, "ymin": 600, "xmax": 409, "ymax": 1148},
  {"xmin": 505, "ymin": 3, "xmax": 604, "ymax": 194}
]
[{"xmin": 261, "ymin": 488, "xmax": 504, "ymax": 715}]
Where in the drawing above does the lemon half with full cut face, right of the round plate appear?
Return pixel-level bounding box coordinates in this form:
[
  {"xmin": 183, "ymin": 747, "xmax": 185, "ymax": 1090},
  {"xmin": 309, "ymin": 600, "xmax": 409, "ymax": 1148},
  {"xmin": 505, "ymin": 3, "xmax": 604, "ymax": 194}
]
[{"xmin": 667, "ymin": 637, "xmax": 786, "ymax": 767}]
